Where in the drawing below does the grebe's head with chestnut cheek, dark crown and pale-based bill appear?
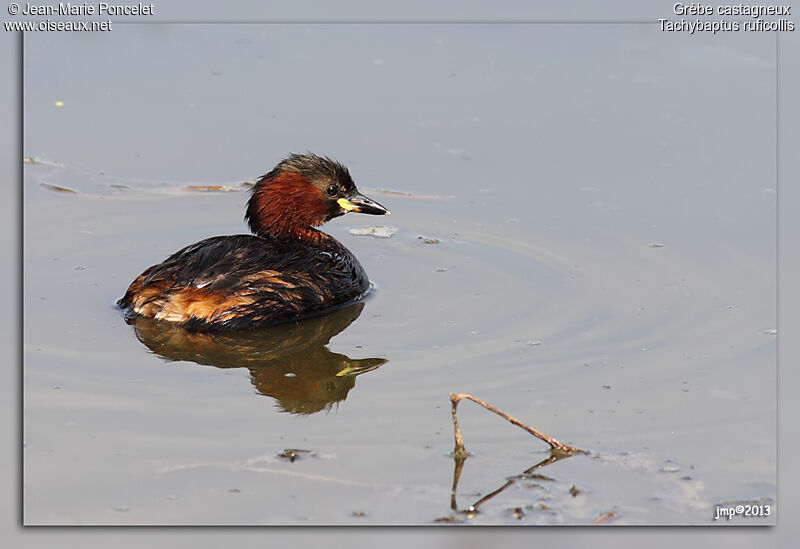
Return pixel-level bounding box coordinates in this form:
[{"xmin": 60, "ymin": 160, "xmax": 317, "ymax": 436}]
[{"xmin": 245, "ymin": 153, "xmax": 389, "ymax": 236}]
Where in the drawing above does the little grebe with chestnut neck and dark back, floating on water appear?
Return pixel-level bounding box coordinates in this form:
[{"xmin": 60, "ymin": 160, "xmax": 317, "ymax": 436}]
[{"xmin": 117, "ymin": 153, "xmax": 389, "ymax": 331}]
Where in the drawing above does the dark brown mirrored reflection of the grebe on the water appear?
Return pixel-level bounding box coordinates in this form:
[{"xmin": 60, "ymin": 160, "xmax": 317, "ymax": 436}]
[{"xmin": 129, "ymin": 302, "xmax": 387, "ymax": 414}]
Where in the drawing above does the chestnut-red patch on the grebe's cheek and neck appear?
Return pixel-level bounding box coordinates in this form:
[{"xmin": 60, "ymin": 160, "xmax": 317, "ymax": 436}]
[{"xmin": 245, "ymin": 171, "xmax": 327, "ymax": 242}]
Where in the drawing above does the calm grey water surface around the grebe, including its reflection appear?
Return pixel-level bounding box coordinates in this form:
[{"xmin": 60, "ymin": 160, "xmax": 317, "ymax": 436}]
[{"xmin": 23, "ymin": 25, "xmax": 776, "ymax": 524}]
